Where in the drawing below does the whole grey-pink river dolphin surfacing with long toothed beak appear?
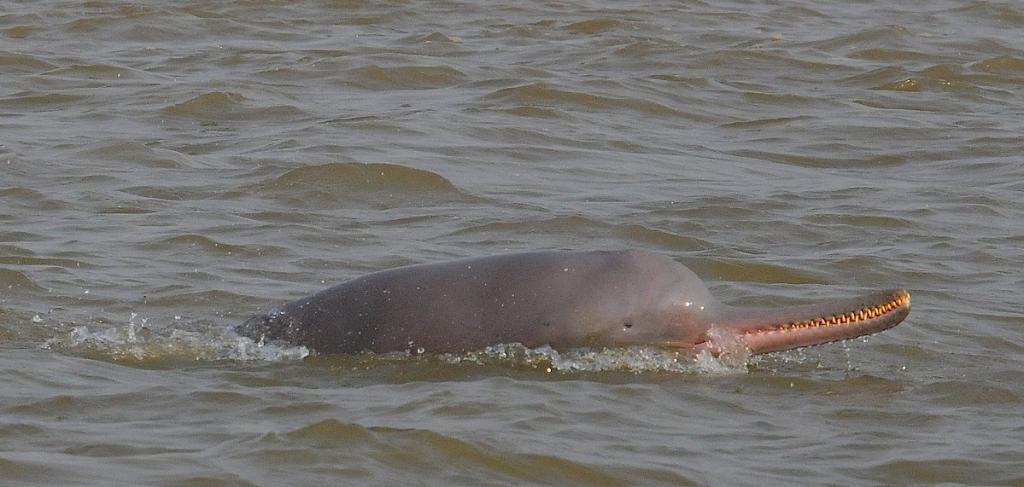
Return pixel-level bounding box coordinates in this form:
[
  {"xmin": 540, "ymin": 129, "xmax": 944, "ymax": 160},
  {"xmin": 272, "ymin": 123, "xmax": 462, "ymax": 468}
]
[{"xmin": 237, "ymin": 251, "xmax": 910, "ymax": 353}]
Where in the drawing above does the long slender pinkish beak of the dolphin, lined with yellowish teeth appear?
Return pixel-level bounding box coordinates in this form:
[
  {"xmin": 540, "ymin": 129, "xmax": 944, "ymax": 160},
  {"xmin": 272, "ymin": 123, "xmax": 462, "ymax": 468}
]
[{"xmin": 697, "ymin": 290, "xmax": 910, "ymax": 354}]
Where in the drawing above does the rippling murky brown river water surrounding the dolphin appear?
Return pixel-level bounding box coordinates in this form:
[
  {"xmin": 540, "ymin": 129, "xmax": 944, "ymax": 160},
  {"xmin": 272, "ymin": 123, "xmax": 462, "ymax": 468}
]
[{"xmin": 0, "ymin": 1, "xmax": 1024, "ymax": 486}]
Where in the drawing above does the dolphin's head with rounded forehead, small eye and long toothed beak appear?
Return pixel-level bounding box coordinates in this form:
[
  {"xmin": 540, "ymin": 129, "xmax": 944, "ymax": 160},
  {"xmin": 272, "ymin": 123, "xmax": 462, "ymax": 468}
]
[{"xmin": 591, "ymin": 254, "xmax": 910, "ymax": 354}]
